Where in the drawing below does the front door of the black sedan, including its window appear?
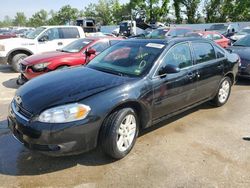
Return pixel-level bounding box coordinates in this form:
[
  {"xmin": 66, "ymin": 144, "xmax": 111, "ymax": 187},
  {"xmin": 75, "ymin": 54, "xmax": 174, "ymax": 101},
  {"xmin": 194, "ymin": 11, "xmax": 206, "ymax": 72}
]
[{"xmin": 153, "ymin": 42, "xmax": 195, "ymax": 119}]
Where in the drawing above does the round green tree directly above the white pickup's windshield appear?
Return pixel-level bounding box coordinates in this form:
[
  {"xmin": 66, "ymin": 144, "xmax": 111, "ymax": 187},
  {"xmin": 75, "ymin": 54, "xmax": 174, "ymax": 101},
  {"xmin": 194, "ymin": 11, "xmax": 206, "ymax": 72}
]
[{"xmin": 28, "ymin": 10, "xmax": 48, "ymax": 27}]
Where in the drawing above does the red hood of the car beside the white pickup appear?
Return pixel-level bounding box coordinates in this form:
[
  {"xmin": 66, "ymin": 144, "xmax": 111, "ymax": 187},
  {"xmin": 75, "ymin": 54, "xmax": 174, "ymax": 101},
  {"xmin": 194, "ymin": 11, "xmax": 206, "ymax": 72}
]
[{"xmin": 23, "ymin": 51, "xmax": 75, "ymax": 65}]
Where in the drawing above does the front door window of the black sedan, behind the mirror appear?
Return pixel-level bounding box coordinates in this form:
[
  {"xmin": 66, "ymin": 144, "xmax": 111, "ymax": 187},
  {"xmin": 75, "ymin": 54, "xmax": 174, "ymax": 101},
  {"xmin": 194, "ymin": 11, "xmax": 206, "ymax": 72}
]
[{"xmin": 160, "ymin": 43, "xmax": 192, "ymax": 71}]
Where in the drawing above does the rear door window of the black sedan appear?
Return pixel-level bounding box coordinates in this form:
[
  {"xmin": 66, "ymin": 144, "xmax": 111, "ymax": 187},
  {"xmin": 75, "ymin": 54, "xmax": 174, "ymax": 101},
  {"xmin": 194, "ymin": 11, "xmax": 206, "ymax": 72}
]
[{"xmin": 193, "ymin": 43, "xmax": 216, "ymax": 64}]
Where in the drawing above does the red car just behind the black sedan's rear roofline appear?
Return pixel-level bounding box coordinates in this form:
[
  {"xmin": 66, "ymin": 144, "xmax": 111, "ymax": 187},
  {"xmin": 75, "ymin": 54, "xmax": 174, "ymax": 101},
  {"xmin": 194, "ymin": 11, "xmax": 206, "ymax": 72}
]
[{"xmin": 185, "ymin": 31, "xmax": 231, "ymax": 48}]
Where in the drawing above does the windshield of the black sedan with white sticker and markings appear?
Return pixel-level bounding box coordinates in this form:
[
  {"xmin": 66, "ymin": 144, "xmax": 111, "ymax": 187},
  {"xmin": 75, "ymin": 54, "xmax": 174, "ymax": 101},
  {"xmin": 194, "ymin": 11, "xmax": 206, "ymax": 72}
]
[{"xmin": 87, "ymin": 40, "xmax": 165, "ymax": 77}]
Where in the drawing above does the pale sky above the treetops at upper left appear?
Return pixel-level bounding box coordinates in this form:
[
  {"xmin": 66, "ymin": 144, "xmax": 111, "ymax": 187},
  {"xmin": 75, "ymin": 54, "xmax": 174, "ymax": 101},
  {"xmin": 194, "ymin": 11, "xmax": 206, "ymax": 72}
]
[{"xmin": 0, "ymin": 0, "xmax": 129, "ymax": 20}]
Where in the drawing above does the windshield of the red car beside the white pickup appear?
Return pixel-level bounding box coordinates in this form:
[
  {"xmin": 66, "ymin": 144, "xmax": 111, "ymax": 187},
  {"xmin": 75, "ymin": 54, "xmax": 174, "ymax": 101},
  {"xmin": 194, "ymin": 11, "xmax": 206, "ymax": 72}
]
[{"xmin": 61, "ymin": 39, "xmax": 93, "ymax": 53}]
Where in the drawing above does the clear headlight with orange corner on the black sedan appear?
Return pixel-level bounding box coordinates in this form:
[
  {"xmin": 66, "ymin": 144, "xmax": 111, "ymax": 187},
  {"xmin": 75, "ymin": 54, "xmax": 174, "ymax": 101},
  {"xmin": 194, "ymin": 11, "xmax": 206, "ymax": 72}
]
[{"xmin": 38, "ymin": 103, "xmax": 91, "ymax": 123}]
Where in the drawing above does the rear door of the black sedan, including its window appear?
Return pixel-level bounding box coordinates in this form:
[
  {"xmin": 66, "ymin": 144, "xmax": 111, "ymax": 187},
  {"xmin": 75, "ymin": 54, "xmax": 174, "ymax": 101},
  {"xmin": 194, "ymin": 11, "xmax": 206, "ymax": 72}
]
[{"xmin": 189, "ymin": 42, "xmax": 225, "ymax": 102}]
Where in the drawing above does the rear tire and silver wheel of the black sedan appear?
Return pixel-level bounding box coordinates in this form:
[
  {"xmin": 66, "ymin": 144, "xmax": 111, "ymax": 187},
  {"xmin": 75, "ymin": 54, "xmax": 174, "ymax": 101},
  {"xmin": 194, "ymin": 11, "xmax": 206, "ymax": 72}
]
[{"xmin": 212, "ymin": 77, "xmax": 232, "ymax": 107}]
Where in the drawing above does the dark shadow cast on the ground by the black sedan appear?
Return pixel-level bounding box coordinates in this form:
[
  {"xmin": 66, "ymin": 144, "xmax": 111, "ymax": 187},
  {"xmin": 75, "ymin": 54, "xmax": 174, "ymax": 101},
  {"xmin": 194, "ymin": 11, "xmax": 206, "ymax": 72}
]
[{"xmin": 0, "ymin": 101, "xmax": 212, "ymax": 176}]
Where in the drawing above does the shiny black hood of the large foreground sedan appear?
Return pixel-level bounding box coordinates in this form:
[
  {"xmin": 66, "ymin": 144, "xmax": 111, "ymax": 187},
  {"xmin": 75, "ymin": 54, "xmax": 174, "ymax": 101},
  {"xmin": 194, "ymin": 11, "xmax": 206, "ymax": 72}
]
[{"xmin": 16, "ymin": 67, "xmax": 134, "ymax": 115}]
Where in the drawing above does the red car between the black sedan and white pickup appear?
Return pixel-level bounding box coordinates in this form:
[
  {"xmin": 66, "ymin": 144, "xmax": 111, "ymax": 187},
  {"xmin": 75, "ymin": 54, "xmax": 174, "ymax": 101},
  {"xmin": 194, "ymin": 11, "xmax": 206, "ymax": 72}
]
[{"xmin": 17, "ymin": 37, "xmax": 122, "ymax": 85}]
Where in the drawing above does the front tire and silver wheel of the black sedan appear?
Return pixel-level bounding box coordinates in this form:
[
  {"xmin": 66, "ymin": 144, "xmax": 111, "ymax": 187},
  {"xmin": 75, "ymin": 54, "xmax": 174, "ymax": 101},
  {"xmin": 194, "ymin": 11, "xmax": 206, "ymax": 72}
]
[{"xmin": 100, "ymin": 108, "xmax": 139, "ymax": 159}]
